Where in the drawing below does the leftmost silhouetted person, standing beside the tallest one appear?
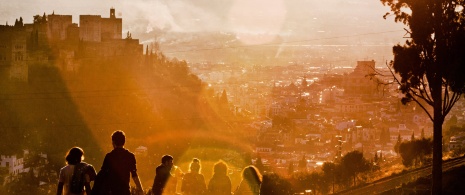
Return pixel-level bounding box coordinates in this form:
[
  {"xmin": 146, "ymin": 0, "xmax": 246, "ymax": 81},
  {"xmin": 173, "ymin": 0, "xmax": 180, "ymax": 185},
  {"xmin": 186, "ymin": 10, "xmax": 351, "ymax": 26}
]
[{"xmin": 57, "ymin": 147, "xmax": 96, "ymax": 195}]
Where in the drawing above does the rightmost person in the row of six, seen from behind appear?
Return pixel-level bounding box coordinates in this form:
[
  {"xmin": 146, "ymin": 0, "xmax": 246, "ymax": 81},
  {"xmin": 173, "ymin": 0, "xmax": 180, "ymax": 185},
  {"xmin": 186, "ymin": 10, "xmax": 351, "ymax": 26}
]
[{"xmin": 234, "ymin": 165, "xmax": 262, "ymax": 195}]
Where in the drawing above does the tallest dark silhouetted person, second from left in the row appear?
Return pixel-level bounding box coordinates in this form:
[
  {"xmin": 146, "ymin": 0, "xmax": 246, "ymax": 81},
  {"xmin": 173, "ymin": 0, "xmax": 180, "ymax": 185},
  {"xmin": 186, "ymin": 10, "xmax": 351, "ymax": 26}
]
[{"xmin": 99, "ymin": 130, "xmax": 143, "ymax": 195}]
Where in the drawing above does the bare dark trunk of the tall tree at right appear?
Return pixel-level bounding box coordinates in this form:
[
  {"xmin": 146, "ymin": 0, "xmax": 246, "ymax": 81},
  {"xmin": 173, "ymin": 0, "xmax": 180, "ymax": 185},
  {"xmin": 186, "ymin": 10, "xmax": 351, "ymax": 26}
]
[{"xmin": 432, "ymin": 84, "xmax": 444, "ymax": 195}]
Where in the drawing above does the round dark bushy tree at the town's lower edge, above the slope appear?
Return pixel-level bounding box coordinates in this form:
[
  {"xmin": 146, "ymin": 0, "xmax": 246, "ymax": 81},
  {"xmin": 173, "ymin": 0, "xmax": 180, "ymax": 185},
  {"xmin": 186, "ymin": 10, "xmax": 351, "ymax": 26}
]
[{"xmin": 341, "ymin": 150, "xmax": 370, "ymax": 186}]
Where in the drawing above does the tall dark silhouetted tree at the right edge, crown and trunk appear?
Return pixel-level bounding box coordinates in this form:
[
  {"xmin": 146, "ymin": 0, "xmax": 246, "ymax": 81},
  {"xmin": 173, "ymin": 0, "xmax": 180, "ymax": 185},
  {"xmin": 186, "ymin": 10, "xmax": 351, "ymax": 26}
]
[{"xmin": 381, "ymin": 0, "xmax": 465, "ymax": 194}]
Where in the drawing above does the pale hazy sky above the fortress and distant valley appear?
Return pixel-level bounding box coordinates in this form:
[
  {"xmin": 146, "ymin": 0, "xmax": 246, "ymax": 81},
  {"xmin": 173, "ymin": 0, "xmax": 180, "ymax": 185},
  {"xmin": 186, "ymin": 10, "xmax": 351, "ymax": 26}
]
[{"xmin": 0, "ymin": 0, "xmax": 403, "ymax": 42}]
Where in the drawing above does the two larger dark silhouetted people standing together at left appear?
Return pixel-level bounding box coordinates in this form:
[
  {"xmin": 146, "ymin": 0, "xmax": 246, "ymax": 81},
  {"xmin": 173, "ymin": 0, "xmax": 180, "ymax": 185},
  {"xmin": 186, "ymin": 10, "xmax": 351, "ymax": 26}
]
[{"xmin": 57, "ymin": 130, "xmax": 143, "ymax": 195}]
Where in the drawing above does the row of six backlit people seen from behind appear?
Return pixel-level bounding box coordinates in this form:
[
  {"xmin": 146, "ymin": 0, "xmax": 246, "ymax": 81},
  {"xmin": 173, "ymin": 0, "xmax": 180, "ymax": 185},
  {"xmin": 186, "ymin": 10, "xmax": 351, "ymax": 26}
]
[{"xmin": 56, "ymin": 130, "xmax": 262, "ymax": 195}]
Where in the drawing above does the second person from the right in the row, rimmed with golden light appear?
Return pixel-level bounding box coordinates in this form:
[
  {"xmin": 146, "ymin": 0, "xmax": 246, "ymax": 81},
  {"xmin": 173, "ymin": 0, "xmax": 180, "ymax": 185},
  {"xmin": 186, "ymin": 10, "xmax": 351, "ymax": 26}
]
[{"xmin": 208, "ymin": 161, "xmax": 231, "ymax": 195}]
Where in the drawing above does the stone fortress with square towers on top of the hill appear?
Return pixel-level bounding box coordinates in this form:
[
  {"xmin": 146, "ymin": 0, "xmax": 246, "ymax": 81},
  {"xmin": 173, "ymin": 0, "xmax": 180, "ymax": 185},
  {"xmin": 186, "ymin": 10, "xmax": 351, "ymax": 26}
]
[{"xmin": 0, "ymin": 8, "xmax": 143, "ymax": 81}]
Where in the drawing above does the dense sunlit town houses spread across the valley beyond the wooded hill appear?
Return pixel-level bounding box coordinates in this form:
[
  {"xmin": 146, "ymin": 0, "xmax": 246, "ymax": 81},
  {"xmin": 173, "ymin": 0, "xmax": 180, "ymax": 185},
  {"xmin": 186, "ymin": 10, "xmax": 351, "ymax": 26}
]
[{"xmin": 197, "ymin": 61, "xmax": 442, "ymax": 172}]
